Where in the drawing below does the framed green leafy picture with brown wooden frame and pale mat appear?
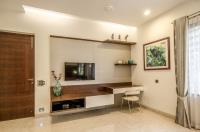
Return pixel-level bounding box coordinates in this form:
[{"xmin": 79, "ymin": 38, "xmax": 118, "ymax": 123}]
[{"xmin": 143, "ymin": 37, "xmax": 170, "ymax": 70}]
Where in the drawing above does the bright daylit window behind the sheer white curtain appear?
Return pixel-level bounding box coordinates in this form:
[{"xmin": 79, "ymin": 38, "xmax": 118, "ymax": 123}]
[{"xmin": 188, "ymin": 16, "xmax": 200, "ymax": 95}]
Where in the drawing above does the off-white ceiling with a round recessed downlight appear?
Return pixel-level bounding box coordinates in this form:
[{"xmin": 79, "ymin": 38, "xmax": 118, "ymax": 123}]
[{"xmin": 0, "ymin": 0, "xmax": 188, "ymax": 26}]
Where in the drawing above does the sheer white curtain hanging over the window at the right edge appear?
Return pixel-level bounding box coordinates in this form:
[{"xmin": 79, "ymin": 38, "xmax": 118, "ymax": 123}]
[{"xmin": 186, "ymin": 16, "xmax": 200, "ymax": 129}]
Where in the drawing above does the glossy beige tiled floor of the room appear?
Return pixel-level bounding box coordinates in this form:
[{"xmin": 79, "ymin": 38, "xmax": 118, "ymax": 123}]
[{"xmin": 0, "ymin": 109, "xmax": 199, "ymax": 132}]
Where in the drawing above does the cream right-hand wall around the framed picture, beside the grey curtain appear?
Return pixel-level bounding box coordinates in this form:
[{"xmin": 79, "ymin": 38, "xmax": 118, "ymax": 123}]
[{"xmin": 132, "ymin": 0, "xmax": 200, "ymax": 115}]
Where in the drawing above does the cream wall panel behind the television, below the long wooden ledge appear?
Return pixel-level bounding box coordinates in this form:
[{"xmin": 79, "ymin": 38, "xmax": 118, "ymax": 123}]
[{"xmin": 50, "ymin": 38, "xmax": 131, "ymax": 85}]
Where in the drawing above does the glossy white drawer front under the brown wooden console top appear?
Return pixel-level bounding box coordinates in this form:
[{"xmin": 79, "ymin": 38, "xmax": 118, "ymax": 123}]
[{"xmin": 85, "ymin": 94, "xmax": 114, "ymax": 108}]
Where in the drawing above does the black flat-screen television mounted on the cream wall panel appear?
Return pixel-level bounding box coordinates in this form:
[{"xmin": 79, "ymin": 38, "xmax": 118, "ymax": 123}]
[{"xmin": 65, "ymin": 62, "xmax": 95, "ymax": 81}]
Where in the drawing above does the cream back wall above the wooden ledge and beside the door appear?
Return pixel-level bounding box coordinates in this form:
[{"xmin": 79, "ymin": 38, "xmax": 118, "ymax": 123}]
[{"xmin": 0, "ymin": 1, "xmax": 137, "ymax": 115}]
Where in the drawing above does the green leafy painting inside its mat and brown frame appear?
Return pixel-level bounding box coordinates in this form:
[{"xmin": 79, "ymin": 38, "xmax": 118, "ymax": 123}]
[{"xmin": 146, "ymin": 45, "xmax": 166, "ymax": 67}]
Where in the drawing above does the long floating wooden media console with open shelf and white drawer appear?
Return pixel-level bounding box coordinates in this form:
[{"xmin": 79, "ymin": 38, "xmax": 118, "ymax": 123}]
[{"xmin": 51, "ymin": 82, "xmax": 142, "ymax": 115}]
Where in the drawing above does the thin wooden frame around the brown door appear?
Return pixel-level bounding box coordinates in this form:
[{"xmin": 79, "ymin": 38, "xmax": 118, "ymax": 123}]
[{"xmin": 0, "ymin": 29, "xmax": 35, "ymax": 117}]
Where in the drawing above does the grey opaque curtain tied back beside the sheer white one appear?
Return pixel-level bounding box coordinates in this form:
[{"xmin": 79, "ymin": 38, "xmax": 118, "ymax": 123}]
[{"xmin": 174, "ymin": 17, "xmax": 191, "ymax": 128}]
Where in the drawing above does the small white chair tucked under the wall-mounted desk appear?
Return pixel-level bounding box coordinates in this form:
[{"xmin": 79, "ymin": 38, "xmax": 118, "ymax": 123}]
[{"xmin": 121, "ymin": 90, "xmax": 141, "ymax": 112}]
